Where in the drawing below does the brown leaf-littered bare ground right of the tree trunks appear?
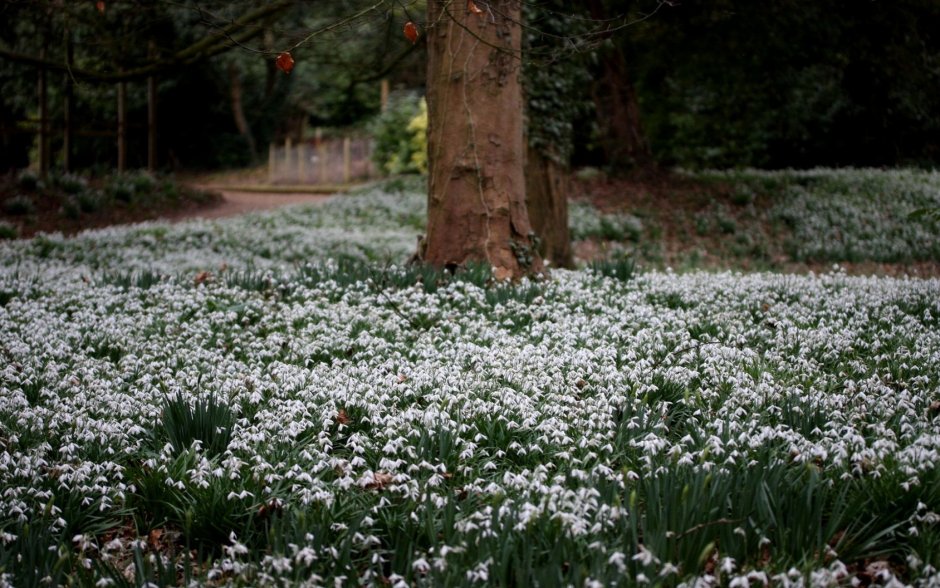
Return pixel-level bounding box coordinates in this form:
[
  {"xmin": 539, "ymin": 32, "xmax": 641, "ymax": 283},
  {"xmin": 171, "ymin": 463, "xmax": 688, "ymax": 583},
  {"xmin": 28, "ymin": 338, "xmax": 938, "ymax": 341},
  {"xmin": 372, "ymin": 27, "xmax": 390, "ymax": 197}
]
[{"xmin": 570, "ymin": 168, "xmax": 940, "ymax": 277}]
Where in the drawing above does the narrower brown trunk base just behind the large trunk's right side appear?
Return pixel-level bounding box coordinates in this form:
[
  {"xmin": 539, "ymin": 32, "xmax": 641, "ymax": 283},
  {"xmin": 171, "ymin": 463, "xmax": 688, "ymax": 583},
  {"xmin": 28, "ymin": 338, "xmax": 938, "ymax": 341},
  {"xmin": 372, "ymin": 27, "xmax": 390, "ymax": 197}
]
[{"xmin": 525, "ymin": 146, "xmax": 574, "ymax": 267}]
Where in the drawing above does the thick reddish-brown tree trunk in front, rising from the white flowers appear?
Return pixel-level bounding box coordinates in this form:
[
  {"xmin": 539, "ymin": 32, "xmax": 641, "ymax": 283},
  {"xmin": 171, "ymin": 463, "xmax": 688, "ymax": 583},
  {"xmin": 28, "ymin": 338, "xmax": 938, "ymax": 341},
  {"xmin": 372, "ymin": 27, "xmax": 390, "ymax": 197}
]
[{"xmin": 418, "ymin": 0, "xmax": 542, "ymax": 279}]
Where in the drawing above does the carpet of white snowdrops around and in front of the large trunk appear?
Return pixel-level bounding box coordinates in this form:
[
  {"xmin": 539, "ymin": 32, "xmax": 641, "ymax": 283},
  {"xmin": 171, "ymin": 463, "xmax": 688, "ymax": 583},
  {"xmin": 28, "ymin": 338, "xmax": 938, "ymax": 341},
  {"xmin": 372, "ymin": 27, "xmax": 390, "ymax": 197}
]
[{"xmin": 0, "ymin": 172, "xmax": 940, "ymax": 586}]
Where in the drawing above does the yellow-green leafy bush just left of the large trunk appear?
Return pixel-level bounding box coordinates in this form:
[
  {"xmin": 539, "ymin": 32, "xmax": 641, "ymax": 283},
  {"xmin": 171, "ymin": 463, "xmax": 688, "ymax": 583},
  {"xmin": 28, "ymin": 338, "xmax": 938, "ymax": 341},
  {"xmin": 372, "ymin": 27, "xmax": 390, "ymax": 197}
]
[{"xmin": 372, "ymin": 94, "xmax": 428, "ymax": 174}]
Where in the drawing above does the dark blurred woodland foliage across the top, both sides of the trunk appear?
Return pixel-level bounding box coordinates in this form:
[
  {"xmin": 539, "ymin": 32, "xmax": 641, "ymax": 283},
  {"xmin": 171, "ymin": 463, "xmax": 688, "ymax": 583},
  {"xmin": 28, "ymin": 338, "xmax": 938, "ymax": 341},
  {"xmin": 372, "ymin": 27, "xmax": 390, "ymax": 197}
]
[{"xmin": 0, "ymin": 0, "xmax": 940, "ymax": 171}]
